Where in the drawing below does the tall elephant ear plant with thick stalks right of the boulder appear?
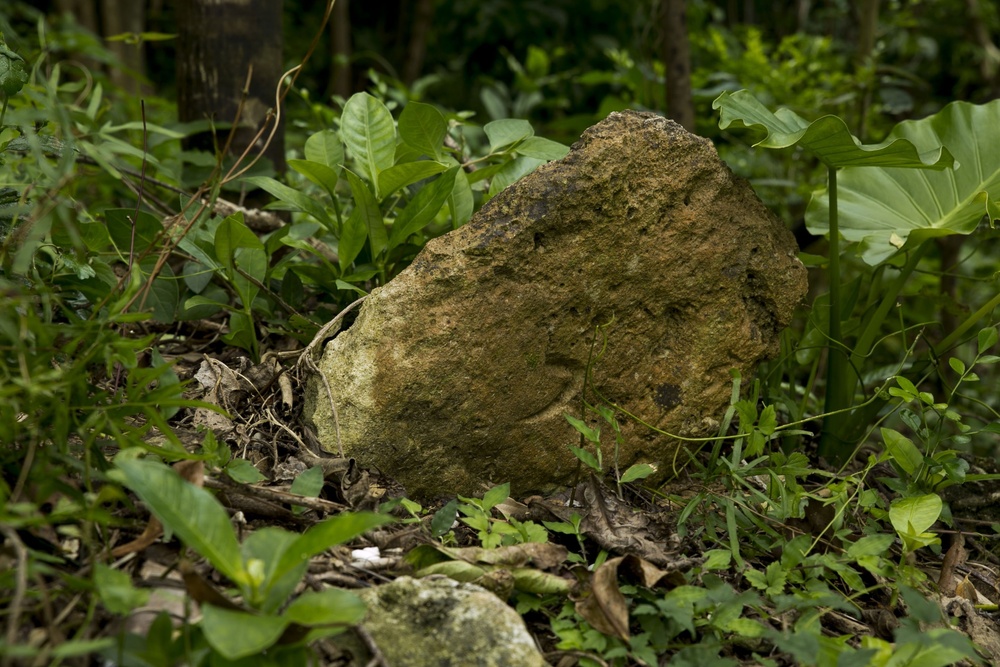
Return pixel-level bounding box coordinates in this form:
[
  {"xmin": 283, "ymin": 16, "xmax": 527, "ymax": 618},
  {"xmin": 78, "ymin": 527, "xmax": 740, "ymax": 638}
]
[{"xmin": 713, "ymin": 91, "xmax": 1000, "ymax": 463}]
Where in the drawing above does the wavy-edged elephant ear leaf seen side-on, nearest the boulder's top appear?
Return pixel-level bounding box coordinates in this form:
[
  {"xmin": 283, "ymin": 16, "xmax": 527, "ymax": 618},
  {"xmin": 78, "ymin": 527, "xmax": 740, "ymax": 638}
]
[{"xmin": 712, "ymin": 90, "xmax": 954, "ymax": 169}]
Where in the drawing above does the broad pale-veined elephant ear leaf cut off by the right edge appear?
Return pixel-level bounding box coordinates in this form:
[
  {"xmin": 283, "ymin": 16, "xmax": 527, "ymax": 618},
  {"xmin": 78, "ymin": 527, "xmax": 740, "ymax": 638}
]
[{"xmin": 806, "ymin": 100, "xmax": 1000, "ymax": 266}]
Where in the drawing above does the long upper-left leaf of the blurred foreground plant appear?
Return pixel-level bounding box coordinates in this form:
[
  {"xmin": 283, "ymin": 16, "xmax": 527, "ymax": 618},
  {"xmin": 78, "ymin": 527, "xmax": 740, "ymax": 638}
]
[{"xmin": 115, "ymin": 460, "xmax": 245, "ymax": 583}]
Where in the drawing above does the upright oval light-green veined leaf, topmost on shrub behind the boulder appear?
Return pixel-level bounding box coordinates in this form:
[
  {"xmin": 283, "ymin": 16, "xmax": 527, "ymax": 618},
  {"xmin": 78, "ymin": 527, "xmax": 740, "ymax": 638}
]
[{"xmin": 340, "ymin": 93, "xmax": 396, "ymax": 196}]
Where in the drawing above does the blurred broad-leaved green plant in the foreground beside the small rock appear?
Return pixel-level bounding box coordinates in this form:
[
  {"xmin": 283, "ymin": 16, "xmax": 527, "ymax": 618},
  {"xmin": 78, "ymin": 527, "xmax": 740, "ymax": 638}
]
[{"xmin": 106, "ymin": 453, "xmax": 391, "ymax": 665}]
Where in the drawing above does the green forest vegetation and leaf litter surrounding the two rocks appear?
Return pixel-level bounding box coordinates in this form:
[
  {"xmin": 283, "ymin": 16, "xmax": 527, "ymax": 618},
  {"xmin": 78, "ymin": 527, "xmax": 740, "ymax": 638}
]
[{"xmin": 0, "ymin": 0, "xmax": 1000, "ymax": 667}]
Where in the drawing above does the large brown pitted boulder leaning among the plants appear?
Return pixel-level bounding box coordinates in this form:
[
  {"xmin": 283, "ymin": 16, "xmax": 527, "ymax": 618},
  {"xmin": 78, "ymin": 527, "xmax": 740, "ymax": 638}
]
[{"xmin": 306, "ymin": 112, "xmax": 806, "ymax": 496}]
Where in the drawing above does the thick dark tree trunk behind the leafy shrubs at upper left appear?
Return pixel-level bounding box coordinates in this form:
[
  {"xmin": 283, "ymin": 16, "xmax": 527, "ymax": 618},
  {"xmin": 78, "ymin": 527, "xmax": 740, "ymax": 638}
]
[{"xmin": 177, "ymin": 0, "xmax": 285, "ymax": 172}]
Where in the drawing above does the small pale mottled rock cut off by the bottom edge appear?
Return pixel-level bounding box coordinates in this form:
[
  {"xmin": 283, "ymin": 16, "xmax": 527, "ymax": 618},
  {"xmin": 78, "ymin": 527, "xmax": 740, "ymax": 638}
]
[{"xmin": 336, "ymin": 576, "xmax": 546, "ymax": 667}]
